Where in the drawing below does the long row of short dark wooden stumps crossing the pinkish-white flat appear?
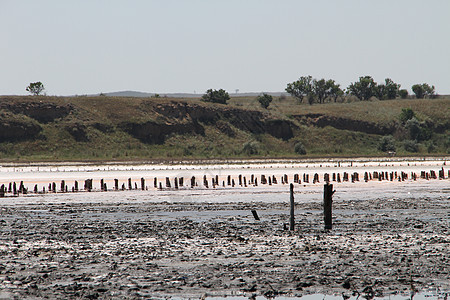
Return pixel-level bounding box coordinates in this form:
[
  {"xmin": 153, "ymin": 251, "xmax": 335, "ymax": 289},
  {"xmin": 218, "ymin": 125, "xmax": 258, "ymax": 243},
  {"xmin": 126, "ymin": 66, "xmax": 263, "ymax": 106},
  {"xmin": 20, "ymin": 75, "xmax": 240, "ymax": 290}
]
[{"xmin": 0, "ymin": 168, "xmax": 450, "ymax": 197}]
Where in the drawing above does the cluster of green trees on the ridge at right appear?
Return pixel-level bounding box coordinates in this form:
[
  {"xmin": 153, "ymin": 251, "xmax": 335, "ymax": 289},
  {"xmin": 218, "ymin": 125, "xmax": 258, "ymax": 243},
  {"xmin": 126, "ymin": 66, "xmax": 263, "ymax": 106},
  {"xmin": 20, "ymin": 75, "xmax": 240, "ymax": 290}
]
[{"xmin": 286, "ymin": 76, "xmax": 437, "ymax": 104}]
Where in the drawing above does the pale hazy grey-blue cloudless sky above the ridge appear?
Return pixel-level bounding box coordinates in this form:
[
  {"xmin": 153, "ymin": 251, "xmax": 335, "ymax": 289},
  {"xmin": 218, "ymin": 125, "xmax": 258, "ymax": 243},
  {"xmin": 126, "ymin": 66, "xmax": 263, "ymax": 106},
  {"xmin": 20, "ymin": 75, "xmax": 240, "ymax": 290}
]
[{"xmin": 0, "ymin": 0, "xmax": 450, "ymax": 95}]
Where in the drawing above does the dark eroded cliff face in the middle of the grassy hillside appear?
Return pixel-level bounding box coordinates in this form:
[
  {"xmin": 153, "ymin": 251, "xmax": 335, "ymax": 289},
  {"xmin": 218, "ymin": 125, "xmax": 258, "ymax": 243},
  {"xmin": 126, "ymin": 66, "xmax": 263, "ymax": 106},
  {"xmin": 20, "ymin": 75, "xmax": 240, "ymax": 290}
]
[{"xmin": 121, "ymin": 101, "xmax": 295, "ymax": 144}]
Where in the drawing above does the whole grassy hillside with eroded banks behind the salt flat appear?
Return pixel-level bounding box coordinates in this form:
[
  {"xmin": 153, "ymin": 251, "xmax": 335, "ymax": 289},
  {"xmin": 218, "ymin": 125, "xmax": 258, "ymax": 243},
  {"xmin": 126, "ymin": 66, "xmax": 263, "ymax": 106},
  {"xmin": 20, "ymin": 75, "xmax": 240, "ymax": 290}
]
[{"xmin": 0, "ymin": 96, "xmax": 450, "ymax": 161}]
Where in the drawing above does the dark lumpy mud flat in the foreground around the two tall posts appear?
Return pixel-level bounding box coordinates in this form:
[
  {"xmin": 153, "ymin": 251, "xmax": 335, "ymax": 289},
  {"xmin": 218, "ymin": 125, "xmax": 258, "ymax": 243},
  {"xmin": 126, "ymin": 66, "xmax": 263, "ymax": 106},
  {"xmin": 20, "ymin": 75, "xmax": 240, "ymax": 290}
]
[{"xmin": 0, "ymin": 159, "xmax": 450, "ymax": 299}]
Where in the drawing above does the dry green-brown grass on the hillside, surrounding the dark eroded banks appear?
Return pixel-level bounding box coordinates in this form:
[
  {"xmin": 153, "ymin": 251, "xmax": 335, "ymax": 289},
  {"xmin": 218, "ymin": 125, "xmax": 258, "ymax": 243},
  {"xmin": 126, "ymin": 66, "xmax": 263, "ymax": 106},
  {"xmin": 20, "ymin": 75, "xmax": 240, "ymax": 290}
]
[{"xmin": 0, "ymin": 96, "xmax": 450, "ymax": 161}]
